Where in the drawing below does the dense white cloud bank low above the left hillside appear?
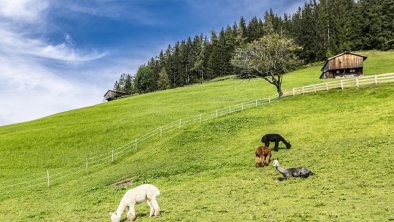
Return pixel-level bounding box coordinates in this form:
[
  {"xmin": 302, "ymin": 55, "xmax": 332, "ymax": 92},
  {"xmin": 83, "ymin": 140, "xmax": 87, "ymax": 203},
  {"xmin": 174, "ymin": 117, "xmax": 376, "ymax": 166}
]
[{"xmin": 0, "ymin": 54, "xmax": 102, "ymax": 125}]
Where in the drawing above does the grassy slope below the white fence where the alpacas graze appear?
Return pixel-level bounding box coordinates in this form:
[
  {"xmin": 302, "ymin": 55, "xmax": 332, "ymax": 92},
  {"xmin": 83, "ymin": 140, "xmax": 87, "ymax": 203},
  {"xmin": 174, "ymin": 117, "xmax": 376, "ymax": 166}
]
[{"xmin": 0, "ymin": 82, "xmax": 394, "ymax": 221}]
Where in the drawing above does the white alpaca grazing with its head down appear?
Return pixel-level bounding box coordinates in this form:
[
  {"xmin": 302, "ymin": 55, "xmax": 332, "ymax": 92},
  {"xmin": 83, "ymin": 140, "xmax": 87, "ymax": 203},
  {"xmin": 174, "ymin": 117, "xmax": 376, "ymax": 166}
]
[{"xmin": 111, "ymin": 184, "xmax": 160, "ymax": 222}]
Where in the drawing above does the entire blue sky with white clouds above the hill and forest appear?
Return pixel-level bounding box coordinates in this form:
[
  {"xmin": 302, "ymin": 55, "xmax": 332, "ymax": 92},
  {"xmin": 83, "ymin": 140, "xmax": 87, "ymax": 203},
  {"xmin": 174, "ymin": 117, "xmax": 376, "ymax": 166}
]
[{"xmin": 0, "ymin": 0, "xmax": 304, "ymax": 125}]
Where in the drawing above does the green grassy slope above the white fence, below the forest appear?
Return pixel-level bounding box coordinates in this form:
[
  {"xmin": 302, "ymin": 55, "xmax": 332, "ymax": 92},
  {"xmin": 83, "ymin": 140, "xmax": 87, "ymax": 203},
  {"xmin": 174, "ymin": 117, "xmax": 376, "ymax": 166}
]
[{"xmin": 0, "ymin": 51, "xmax": 394, "ymax": 179}]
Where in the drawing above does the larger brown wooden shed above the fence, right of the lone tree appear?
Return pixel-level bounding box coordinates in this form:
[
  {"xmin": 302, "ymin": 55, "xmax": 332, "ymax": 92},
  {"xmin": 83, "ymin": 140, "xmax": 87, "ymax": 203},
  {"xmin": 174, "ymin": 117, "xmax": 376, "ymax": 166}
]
[{"xmin": 320, "ymin": 52, "xmax": 367, "ymax": 79}]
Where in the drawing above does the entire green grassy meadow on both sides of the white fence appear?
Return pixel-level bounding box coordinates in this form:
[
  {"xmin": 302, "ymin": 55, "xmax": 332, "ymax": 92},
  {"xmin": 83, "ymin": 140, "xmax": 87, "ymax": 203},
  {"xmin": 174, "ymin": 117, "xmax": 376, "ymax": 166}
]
[{"xmin": 0, "ymin": 51, "xmax": 394, "ymax": 221}]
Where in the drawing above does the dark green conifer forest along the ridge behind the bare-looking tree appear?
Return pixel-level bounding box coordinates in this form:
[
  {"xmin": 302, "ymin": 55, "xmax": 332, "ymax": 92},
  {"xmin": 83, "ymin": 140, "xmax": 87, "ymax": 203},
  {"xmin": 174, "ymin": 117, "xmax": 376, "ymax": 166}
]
[{"xmin": 114, "ymin": 0, "xmax": 394, "ymax": 93}]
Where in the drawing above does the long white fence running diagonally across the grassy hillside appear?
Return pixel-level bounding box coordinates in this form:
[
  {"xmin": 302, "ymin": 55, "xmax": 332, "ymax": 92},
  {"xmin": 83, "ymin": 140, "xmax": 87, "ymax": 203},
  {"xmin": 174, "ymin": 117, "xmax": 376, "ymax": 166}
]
[{"xmin": 0, "ymin": 73, "xmax": 394, "ymax": 195}]
